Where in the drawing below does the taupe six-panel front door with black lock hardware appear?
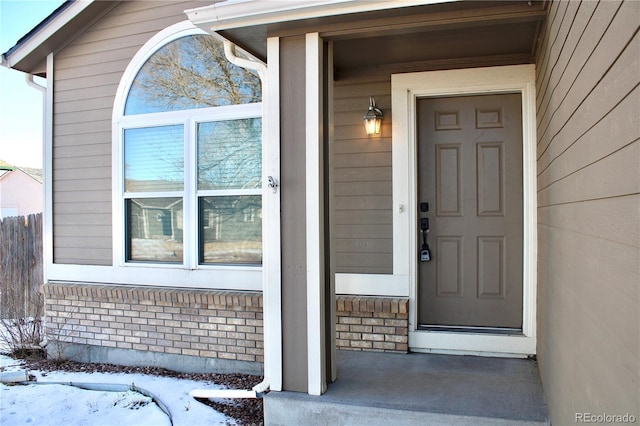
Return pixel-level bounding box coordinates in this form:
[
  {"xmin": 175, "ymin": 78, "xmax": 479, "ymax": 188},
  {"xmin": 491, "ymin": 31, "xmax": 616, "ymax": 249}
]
[{"xmin": 416, "ymin": 94, "xmax": 523, "ymax": 330}]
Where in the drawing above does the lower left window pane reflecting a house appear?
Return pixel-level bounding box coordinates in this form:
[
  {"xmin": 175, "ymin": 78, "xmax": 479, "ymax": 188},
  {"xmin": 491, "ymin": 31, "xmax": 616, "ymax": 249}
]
[{"xmin": 125, "ymin": 198, "xmax": 183, "ymax": 263}]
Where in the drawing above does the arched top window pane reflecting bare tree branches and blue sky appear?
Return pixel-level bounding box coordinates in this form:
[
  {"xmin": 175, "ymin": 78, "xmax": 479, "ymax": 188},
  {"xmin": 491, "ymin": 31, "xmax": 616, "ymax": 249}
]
[{"xmin": 125, "ymin": 35, "xmax": 261, "ymax": 115}]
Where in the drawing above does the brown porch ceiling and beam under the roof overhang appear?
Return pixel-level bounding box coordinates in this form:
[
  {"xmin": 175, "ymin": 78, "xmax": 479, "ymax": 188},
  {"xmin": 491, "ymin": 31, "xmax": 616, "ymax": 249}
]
[{"xmin": 220, "ymin": 1, "xmax": 546, "ymax": 79}]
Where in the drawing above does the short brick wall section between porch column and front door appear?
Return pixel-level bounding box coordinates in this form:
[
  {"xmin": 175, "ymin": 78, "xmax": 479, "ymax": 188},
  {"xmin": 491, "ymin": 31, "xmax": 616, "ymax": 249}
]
[{"xmin": 336, "ymin": 296, "xmax": 409, "ymax": 353}]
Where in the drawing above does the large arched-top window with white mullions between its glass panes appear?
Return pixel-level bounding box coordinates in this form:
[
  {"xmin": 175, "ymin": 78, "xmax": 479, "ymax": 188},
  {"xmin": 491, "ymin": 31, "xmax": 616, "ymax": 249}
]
[{"xmin": 117, "ymin": 33, "xmax": 262, "ymax": 269}]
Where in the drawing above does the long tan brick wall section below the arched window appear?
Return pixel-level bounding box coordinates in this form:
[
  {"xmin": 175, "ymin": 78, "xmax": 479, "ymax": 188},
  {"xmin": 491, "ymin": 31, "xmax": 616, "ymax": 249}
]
[{"xmin": 43, "ymin": 283, "xmax": 264, "ymax": 362}]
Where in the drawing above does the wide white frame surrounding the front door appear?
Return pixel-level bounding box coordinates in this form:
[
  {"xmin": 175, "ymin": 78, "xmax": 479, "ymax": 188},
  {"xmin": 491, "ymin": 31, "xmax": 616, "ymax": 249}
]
[{"xmin": 391, "ymin": 65, "xmax": 537, "ymax": 356}]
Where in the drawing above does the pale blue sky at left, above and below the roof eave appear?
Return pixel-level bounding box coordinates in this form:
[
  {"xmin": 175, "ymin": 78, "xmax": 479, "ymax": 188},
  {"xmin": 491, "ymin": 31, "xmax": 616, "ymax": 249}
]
[{"xmin": 0, "ymin": 0, "xmax": 64, "ymax": 168}]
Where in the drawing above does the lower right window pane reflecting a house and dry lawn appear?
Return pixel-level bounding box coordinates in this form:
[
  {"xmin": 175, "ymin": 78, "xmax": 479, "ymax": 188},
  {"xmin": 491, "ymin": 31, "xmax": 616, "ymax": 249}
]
[{"xmin": 199, "ymin": 195, "xmax": 262, "ymax": 264}]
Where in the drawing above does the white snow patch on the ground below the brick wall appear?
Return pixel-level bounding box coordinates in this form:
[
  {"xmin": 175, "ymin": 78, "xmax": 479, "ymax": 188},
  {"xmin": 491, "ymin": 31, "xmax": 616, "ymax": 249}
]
[{"xmin": 0, "ymin": 355, "xmax": 235, "ymax": 426}]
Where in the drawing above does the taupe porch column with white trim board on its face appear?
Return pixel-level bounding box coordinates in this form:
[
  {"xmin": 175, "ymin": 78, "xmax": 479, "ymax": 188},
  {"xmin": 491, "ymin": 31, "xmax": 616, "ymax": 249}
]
[{"xmin": 280, "ymin": 34, "xmax": 328, "ymax": 395}]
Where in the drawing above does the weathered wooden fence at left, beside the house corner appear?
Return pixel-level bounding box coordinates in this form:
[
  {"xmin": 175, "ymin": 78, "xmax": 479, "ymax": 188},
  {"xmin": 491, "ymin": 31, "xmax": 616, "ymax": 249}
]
[{"xmin": 0, "ymin": 213, "xmax": 44, "ymax": 319}]
